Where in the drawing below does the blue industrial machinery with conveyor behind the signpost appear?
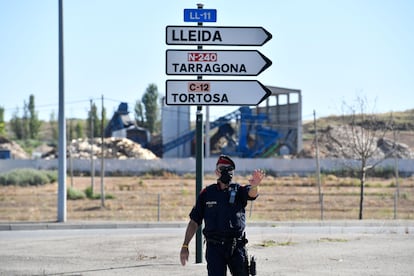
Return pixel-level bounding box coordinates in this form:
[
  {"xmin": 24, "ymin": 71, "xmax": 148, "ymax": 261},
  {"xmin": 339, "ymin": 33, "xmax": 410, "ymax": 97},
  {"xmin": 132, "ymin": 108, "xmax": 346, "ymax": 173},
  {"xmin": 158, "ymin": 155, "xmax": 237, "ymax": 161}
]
[{"xmin": 105, "ymin": 103, "xmax": 295, "ymax": 158}]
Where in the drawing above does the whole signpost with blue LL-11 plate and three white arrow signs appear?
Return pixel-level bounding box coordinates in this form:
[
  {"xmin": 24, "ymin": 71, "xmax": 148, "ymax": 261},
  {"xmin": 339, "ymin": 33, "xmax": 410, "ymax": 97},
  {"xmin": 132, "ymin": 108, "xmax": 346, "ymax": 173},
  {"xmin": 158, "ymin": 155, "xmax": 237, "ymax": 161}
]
[{"xmin": 165, "ymin": 4, "xmax": 272, "ymax": 263}]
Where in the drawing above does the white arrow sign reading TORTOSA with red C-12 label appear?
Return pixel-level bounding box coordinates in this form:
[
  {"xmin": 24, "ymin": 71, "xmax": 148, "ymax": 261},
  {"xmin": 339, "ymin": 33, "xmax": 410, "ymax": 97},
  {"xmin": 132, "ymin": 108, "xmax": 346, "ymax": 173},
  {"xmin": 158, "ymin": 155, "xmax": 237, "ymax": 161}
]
[{"xmin": 166, "ymin": 80, "xmax": 272, "ymax": 105}]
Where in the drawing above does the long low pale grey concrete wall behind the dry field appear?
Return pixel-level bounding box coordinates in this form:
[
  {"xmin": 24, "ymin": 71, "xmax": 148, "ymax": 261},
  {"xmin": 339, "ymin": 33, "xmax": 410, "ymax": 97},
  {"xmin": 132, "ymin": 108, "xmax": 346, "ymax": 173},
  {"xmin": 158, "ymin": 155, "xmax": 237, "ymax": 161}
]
[{"xmin": 0, "ymin": 158, "xmax": 414, "ymax": 175}]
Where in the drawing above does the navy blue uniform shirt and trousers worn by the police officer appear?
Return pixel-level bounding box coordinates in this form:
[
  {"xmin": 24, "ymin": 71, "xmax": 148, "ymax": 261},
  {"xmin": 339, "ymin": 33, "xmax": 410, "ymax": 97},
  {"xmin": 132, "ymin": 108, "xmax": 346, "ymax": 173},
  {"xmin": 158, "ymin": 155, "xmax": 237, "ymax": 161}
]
[{"xmin": 190, "ymin": 183, "xmax": 256, "ymax": 276}]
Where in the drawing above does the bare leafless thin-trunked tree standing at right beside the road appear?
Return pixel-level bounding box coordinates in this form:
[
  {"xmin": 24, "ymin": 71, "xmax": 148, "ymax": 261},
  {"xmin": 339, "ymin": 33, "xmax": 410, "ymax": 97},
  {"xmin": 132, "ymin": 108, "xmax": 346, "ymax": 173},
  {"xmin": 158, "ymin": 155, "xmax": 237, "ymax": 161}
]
[{"xmin": 343, "ymin": 97, "xmax": 392, "ymax": 220}]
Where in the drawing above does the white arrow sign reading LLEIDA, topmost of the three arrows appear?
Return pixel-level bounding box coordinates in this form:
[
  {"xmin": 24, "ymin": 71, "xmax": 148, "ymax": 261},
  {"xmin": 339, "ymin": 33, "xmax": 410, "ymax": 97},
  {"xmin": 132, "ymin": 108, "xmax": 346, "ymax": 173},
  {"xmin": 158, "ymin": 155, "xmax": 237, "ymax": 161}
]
[{"xmin": 166, "ymin": 26, "xmax": 272, "ymax": 46}]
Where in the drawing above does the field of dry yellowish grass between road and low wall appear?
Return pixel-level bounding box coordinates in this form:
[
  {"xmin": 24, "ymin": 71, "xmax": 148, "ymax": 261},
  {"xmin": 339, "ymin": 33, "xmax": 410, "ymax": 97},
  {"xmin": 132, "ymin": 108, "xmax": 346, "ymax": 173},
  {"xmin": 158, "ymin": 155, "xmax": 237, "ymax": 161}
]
[{"xmin": 0, "ymin": 175, "xmax": 414, "ymax": 222}]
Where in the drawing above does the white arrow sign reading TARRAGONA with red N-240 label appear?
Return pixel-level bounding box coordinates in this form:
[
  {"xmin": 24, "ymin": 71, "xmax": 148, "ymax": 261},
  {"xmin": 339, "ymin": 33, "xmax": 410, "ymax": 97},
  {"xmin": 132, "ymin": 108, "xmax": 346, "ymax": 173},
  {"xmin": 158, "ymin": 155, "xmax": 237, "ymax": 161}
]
[{"xmin": 165, "ymin": 50, "xmax": 272, "ymax": 76}]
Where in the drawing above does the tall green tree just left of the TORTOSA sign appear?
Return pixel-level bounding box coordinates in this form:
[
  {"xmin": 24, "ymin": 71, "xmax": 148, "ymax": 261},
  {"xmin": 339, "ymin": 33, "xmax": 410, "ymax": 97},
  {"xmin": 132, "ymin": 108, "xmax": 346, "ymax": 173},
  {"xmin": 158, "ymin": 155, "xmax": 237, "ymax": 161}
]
[{"xmin": 142, "ymin": 84, "xmax": 159, "ymax": 133}]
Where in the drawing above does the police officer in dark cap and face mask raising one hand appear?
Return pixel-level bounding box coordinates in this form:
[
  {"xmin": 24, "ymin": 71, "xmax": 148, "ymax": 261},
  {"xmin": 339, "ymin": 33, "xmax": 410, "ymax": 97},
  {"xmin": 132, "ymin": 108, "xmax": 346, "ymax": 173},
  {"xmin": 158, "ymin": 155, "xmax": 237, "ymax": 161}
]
[{"xmin": 180, "ymin": 155, "xmax": 264, "ymax": 276}]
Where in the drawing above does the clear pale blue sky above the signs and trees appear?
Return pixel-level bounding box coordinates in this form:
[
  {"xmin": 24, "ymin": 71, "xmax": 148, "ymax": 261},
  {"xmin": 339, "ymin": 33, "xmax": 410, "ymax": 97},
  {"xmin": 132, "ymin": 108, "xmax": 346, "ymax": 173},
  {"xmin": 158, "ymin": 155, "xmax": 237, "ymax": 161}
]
[{"xmin": 0, "ymin": 0, "xmax": 414, "ymax": 121}]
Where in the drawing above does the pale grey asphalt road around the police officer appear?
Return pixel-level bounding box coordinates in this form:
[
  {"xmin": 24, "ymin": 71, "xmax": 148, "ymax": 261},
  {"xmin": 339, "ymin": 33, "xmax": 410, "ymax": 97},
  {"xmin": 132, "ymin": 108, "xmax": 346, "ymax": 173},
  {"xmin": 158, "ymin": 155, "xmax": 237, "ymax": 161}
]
[{"xmin": 0, "ymin": 221, "xmax": 414, "ymax": 276}]
